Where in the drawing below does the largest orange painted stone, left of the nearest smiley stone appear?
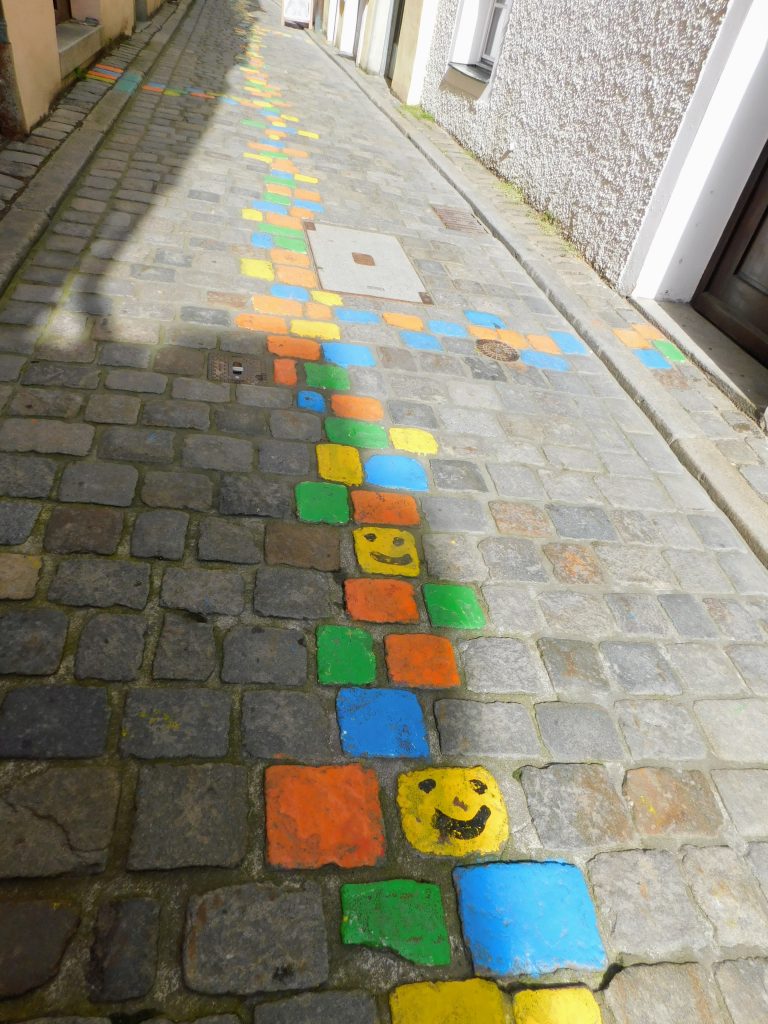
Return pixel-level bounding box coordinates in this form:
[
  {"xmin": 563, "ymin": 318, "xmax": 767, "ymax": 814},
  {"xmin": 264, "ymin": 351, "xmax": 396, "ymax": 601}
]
[{"xmin": 264, "ymin": 764, "xmax": 385, "ymax": 867}]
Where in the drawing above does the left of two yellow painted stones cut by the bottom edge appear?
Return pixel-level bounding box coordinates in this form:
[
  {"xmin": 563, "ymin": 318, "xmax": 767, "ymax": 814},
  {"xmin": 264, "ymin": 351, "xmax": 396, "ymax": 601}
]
[{"xmin": 389, "ymin": 978, "xmax": 512, "ymax": 1024}]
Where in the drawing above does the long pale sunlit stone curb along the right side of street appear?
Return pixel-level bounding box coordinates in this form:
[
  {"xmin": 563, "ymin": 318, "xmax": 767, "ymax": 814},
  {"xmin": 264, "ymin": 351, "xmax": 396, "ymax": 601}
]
[{"xmin": 307, "ymin": 32, "xmax": 768, "ymax": 565}]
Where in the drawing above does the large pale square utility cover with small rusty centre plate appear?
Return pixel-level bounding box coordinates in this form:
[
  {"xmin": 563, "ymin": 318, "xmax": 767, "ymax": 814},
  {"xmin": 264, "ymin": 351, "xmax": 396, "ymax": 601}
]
[{"xmin": 307, "ymin": 222, "xmax": 424, "ymax": 302}]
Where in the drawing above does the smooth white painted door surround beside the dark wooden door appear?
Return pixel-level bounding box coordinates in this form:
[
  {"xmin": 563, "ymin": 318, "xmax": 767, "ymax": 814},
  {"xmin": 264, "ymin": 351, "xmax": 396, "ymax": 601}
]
[{"xmin": 618, "ymin": 0, "xmax": 768, "ymax": 302}]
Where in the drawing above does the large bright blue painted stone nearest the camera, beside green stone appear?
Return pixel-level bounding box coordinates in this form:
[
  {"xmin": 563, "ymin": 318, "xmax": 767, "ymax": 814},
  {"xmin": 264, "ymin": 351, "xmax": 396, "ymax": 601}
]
[{"xmin": 454, "ymin": 860, "xmax": 607, "ymax": 978}]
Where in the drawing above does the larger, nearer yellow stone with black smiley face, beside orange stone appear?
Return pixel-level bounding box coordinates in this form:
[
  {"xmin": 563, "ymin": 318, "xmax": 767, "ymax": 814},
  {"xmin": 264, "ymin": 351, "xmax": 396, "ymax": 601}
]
[{"xmin": 397, "ymin": 767, "xmax": 509, "ymax": 857}]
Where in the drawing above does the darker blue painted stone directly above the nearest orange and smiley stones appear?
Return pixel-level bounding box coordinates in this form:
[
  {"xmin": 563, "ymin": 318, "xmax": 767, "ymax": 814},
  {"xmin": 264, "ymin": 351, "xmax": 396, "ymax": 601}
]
[{"xmin": 336, "ymin": 686, "xmax": 429, "ymax": 758}]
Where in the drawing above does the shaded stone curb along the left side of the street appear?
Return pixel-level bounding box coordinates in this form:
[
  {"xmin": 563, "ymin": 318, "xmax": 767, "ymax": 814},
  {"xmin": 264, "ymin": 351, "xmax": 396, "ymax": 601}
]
[{"xmin": 0, "ymin": 0, "xmax": 197, "ymax": 295}]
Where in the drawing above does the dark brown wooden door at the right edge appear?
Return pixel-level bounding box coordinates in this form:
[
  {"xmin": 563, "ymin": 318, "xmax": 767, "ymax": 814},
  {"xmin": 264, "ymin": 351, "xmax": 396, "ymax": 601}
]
[{"xmin": 691, "ymin": 145, "xmax": 768, "ymax": 366}]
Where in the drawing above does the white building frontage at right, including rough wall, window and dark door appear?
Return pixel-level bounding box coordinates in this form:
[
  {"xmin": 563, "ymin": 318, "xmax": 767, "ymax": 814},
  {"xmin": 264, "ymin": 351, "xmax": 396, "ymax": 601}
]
[{"xmin": 315, "ymin": 0, "xmax": 768, "ymax": 361}]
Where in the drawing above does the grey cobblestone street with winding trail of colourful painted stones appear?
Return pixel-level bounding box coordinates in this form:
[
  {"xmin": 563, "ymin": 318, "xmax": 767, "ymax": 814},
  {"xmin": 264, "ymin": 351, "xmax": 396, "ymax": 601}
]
[{"xmin": 0, "ymin": 0, "xmax": 768, "ymax": 1024}]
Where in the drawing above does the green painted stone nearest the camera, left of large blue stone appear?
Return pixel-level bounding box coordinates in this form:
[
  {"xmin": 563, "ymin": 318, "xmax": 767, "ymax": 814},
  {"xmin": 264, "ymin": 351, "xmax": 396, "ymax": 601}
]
[{"xmin": 341, "ymin": 879, "xmax": 451, "ymax": 967}]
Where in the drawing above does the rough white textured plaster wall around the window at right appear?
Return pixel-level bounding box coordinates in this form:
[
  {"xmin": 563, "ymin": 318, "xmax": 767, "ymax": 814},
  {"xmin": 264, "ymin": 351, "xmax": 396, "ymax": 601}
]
[{"xmin": 422, "ymin": 0, "xmax": 728, "ymax": 282}]
